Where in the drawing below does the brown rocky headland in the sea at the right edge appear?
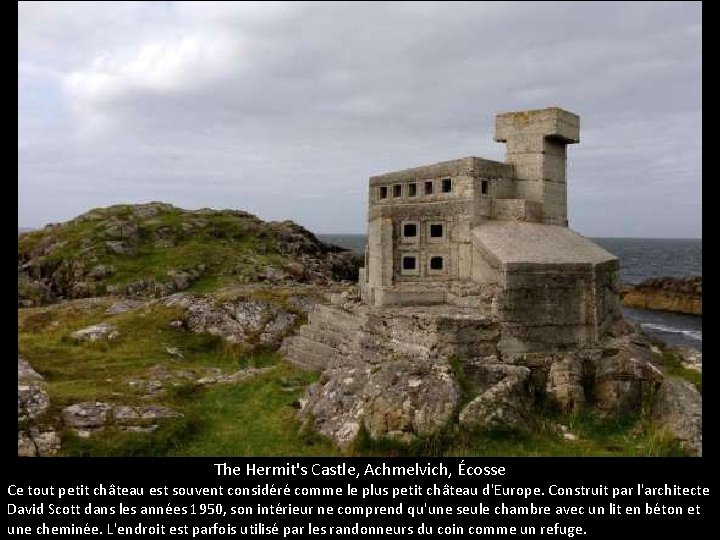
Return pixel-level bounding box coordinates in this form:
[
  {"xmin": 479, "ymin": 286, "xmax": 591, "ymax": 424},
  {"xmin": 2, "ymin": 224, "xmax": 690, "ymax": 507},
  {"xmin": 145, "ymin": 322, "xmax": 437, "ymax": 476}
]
[{"xmin": 620, "ymin": 276, "xmax": 702, "ymax": 316}]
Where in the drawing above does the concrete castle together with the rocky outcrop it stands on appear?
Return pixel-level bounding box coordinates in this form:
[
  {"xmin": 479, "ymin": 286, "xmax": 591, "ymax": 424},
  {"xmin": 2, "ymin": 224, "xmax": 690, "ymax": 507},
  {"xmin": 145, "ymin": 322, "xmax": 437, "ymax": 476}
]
[{"xmin": 282, "ymin": 107, "xmax": 701, "ymax": 452}]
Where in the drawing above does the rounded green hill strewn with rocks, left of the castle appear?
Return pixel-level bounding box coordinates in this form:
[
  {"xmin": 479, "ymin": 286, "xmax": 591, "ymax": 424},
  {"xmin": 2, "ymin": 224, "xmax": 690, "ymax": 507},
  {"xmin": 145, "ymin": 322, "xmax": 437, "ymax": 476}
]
[{"xmin": 18, "ymin": 202, "xmax": 357, "ymax": 307}]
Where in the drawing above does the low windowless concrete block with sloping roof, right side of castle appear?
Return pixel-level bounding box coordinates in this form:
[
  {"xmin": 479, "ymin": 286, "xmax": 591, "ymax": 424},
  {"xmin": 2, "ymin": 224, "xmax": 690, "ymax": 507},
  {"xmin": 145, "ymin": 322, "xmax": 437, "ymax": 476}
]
[{"xmin": 473, "ymin": 221, "xmax": 619, "ymax": 354}]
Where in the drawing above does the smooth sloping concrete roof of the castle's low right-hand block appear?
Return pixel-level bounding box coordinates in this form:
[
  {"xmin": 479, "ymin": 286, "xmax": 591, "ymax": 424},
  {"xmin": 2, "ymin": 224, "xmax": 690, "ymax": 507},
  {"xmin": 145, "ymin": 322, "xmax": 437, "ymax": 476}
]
[{"xmin": 473, "ymin": 221, "xmax": 617, "ymax": 265}]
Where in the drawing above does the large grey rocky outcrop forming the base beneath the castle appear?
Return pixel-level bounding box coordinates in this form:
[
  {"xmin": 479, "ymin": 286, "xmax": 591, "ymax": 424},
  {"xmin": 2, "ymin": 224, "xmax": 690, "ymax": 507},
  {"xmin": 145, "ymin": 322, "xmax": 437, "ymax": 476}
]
[{"xmin": 281, "ymin": 291, "xmax": 701, "ymax": 452}]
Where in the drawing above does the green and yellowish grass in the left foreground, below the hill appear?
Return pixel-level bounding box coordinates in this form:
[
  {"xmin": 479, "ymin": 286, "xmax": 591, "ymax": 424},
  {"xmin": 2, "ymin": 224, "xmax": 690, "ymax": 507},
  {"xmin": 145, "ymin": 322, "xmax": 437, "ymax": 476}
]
[{"xmin": 18, "ymin": 300, "xmax": 339, "ymax": 456}]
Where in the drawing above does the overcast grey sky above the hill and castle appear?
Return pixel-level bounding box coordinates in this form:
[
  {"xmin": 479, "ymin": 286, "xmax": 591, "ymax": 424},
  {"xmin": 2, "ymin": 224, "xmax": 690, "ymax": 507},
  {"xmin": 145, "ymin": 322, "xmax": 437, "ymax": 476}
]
[{"xmin": 18, "ymin": 2, "xmax": 702, "ymax": 237}]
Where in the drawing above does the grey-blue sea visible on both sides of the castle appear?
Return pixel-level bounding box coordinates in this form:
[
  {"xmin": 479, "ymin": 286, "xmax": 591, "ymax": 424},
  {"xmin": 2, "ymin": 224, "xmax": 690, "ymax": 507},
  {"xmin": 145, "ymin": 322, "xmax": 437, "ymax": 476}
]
[{"xmin": 317, "ymin": 234, "xmax": 702, "ymax": 351}]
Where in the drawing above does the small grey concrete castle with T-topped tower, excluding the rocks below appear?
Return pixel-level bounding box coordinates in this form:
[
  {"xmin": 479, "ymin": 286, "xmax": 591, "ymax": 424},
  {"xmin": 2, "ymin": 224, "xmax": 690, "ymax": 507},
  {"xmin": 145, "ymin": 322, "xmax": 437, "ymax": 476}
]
[{"xmin": 360, "ymin": 107, "xmax": 620, "ymax": 351}]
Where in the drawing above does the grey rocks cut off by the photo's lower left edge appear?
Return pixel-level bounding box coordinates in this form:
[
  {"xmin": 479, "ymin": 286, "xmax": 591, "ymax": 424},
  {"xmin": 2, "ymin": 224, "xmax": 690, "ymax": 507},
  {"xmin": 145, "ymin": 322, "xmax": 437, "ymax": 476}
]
[{"xmin": 18, "ymin": 357, "xmax": 60, "ymax": 457}]
